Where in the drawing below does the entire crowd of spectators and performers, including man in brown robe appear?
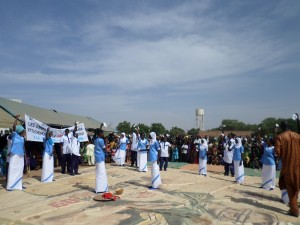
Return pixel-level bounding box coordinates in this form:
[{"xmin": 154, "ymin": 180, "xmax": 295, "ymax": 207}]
[{"xmin": 1, "ymin": 115, "xmax": 300, "ymax": 216}]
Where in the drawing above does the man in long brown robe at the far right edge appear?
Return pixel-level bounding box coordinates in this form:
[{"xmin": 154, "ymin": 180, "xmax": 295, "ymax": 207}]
[{"xmin": 275, "ymin": 121, "xmax": 300, "ymax": 217}]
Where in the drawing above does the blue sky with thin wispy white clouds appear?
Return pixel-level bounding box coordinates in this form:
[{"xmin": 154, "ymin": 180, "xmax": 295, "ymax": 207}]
[{"xmin": 0, "ymin": 0, "xmax": 300, "ymax": 131}]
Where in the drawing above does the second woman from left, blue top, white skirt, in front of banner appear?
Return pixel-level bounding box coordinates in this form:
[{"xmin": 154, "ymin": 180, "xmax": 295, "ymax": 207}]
[{"xmin": 41, "ymin": 127, "xmax": 54, "ymax": 182}]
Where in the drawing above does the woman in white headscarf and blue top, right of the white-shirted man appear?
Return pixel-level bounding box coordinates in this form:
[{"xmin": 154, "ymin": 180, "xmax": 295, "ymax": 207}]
[{"xmin": 233, "ymin": 137, "xmax": 245, "ymax": 184}]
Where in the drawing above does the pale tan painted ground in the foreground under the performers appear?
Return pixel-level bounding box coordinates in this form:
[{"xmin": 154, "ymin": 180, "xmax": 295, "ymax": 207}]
[{"xmin": 0, "ymin": 164, "xmax": 300, "ymax": 225}]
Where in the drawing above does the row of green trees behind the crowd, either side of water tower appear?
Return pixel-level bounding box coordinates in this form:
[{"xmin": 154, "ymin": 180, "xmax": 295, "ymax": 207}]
[{"xmin": 116, "ymin": 117, "xmax": 298, "ymax": 136}]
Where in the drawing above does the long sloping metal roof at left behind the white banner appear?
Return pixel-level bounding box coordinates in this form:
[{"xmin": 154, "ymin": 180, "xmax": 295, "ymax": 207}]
[{"xmin": 0, "ymin": 97, "xmax": 114, "ymax": 132}]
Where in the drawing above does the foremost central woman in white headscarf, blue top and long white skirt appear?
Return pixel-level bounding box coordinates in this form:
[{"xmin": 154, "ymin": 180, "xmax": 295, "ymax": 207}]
[{"xmin": 148, "ymin": 132, "xmax": 161, "ymax": 189}]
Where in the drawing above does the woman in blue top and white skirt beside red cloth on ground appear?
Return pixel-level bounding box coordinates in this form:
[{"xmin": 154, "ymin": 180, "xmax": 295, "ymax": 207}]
[{"xmin": 94, "ymin": 129, "xmax": 108, "ymax": 194}]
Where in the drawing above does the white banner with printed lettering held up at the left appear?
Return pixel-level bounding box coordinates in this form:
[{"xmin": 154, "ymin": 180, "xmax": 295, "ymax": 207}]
[{"xmin": 25, "ymin": 114, "xmax": 88, "ymax": 143}]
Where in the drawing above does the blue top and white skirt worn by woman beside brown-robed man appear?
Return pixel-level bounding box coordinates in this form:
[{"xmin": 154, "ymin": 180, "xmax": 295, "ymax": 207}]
[{"xmin": 261, "ymin": 142, "xmax": 276, "ymax": 190}]
